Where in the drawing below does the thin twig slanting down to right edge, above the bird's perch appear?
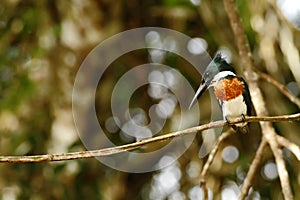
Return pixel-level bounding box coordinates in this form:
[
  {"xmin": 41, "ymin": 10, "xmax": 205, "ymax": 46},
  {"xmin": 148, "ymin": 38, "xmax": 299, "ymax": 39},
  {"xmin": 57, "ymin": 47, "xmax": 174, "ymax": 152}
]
[{"xmin": 256, "ymin": 71, "xmax": 300, "ymax": 108}]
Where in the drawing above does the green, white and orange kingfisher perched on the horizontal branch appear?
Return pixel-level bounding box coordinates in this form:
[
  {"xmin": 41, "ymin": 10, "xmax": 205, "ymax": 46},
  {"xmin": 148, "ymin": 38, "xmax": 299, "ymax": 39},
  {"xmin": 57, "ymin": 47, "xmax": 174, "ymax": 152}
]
[{"xmin": 189, "ymin": 53, "xmax": 252, "ymax": 133}]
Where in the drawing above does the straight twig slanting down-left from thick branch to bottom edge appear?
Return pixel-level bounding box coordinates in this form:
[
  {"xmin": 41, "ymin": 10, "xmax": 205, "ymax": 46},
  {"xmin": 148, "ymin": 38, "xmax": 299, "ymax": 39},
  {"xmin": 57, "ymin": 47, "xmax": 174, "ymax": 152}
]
[{"xmin": 239, "ymin": 138, "xmax": 268, "ymax": 200}]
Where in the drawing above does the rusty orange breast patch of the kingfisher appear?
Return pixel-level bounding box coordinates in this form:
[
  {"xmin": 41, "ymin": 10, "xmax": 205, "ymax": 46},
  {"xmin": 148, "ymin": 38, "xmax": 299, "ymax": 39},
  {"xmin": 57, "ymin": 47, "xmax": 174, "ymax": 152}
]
[{"xmin": 214, "ymin": 77, "xmax": 244, "ymax": 101}]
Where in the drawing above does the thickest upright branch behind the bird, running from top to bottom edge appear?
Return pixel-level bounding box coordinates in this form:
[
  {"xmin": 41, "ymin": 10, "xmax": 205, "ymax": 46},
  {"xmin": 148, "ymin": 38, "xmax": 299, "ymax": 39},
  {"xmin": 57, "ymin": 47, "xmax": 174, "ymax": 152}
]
[{"xmin": 223, "ymin": 0, "xmax": 293, "ymax": 200}]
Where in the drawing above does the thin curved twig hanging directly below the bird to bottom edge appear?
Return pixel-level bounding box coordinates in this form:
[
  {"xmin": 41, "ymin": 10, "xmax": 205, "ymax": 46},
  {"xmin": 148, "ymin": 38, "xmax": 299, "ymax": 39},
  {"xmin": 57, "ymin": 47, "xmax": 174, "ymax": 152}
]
[{"xmin": 200, "ymin": 129, "xmax": 234, "ymax": 200}]
